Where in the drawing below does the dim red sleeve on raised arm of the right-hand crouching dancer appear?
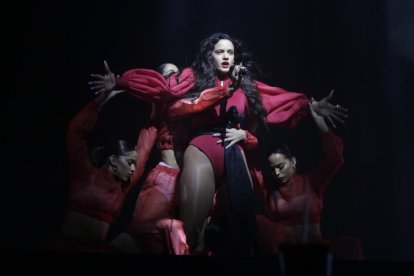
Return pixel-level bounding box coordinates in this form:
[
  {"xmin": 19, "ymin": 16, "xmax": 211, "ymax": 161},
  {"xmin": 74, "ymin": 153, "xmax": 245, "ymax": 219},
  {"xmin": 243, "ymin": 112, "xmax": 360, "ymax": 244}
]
[{"xmin": 311, "ymin": 131, "xmax": 344, "ymax": 193}]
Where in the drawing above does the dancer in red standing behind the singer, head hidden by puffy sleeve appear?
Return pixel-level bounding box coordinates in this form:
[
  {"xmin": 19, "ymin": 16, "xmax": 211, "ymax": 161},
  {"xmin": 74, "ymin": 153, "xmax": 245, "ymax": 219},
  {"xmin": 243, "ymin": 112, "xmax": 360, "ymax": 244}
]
[{"xmin": 111, "ymin": 63, "xmax": 188, "ymax": 255}]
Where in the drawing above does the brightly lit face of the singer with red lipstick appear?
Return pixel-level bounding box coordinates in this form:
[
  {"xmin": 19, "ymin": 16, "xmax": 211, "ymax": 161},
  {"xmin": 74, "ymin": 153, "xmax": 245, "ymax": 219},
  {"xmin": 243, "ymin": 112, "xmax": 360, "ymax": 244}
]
[{"xmin": 212, "ymin": 39, "xmax": 234, "ymax": 74}]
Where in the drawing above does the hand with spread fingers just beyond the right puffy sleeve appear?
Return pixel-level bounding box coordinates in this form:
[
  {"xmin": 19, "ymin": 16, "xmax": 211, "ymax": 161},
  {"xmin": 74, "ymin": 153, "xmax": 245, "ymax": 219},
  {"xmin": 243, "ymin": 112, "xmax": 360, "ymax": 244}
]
[{"xmin": 311, "ymin": 89, "xmax": 348, "ymax": 127}]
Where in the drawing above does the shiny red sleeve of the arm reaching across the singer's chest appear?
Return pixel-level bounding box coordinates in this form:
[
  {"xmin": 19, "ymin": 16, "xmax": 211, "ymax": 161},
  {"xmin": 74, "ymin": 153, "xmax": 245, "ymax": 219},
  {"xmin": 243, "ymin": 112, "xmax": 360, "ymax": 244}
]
[{"xmin": 167, "ymin": 86, "xmax": 229, "ymax": 120}]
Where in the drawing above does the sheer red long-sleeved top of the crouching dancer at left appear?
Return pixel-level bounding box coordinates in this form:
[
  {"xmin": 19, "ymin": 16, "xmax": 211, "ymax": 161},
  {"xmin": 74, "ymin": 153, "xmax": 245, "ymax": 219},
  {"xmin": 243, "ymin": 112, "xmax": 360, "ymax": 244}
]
[{"xmin": 66, "ymin": 101, "xmax": 156, "ymax": 224}]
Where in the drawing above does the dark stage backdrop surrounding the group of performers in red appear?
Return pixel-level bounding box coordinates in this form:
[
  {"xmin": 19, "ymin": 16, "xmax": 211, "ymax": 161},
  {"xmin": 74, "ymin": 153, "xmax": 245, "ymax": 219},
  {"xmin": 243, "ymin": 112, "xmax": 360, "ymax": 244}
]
[{"xmin": 8, "ymin": 0, "xmax": 414, "ymax": 266}]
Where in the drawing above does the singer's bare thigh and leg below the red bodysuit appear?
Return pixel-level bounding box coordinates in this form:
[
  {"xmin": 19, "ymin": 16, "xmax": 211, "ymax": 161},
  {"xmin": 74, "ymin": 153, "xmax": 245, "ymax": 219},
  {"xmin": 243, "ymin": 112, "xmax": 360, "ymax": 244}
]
[{"xmin": 179, "ymin": 145, "xmax": 215, "ymax": 250}]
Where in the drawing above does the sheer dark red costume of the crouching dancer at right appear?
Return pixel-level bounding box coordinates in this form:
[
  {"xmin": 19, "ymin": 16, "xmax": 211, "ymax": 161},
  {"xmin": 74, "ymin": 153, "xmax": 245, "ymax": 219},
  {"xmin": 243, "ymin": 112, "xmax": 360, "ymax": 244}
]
[{"xmin": 256, "ymin": 131, "xmax": 344, "ymax": 252}]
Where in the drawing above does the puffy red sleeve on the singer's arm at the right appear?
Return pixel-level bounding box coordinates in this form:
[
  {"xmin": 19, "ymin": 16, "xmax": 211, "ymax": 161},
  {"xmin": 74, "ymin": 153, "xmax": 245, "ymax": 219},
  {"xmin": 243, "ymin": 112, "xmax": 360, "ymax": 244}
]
[{"xmin": 257, "ymin": 82, "xmax": 309, "ymax": 128}]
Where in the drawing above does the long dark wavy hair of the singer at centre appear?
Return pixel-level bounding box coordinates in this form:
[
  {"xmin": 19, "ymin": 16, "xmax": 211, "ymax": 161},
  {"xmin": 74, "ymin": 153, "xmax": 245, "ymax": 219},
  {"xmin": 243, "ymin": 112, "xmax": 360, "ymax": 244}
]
[{"xmin": 187, "ymin": 33, "xmax": 267, "ymax": 133}]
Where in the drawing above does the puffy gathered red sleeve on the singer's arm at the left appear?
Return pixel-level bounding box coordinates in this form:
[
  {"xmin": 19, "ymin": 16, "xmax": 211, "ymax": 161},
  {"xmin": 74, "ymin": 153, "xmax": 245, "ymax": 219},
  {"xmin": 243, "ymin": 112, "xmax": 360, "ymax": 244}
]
[{"xmin": 116, "ymin": 68, "xmax": 194, "ymax": 102}]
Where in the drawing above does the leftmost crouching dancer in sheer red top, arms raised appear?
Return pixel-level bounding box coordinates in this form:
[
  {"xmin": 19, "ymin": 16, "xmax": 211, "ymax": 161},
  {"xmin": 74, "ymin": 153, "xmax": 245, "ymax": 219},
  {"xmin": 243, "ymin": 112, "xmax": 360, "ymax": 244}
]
[{"xmin": 48, "ymin": 88, "xmax": 156, "ymax": 252}]
